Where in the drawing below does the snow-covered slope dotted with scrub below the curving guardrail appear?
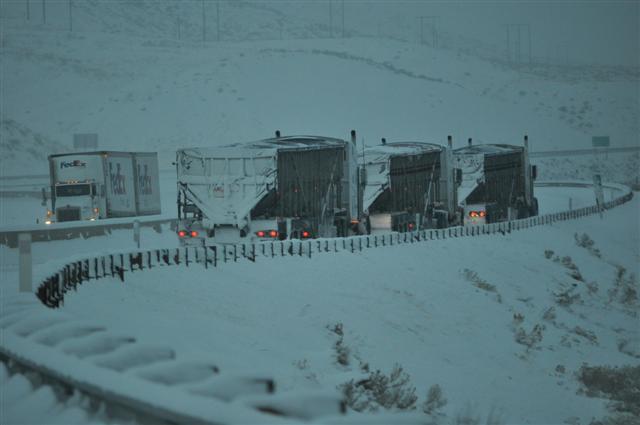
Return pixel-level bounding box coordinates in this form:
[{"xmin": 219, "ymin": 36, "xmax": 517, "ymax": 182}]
[{"xmin": 2, "ymin": 190, "xmax": 640, "ymax": 424}]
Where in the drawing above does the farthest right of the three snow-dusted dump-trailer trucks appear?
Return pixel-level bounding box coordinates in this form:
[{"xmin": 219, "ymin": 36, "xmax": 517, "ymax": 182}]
[{"xmin": 454, "ymin": 136, "xmax": 538, "ymax": 225}]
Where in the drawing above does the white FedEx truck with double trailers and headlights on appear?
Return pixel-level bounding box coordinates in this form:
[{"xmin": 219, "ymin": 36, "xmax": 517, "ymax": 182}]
[{"xmin": 45, "ymin": 151, "xmax": 160, "ymax": 224}]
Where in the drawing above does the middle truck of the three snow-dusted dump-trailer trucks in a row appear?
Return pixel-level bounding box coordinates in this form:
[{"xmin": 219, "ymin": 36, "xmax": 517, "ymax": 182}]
[{"xmin": 361, "ymin": 139, "xmax": 460, "ymax": 232}]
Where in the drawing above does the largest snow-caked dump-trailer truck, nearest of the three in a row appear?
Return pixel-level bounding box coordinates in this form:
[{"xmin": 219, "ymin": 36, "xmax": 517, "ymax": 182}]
[{"xmin": 176, "ymin": 131, "xmax": 360, "ymax": 245}]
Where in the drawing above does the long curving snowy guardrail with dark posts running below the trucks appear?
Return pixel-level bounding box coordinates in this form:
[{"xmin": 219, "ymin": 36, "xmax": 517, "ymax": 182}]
[{"xmin": 36, "ymin": 190, "xmax": 633, "ymax": 308}]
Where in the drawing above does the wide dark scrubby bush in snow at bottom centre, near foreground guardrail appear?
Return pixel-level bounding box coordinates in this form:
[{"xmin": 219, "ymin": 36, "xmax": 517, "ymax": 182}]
[{"xmin": 341, "ymin": 364, "xmax": 418, "ymax": 412}]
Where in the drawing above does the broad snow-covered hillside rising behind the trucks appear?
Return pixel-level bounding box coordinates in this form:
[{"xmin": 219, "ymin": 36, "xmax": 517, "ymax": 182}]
[{"xmin": 1, "ymin": 2, "xmax": 639, "ymax": 175}]
